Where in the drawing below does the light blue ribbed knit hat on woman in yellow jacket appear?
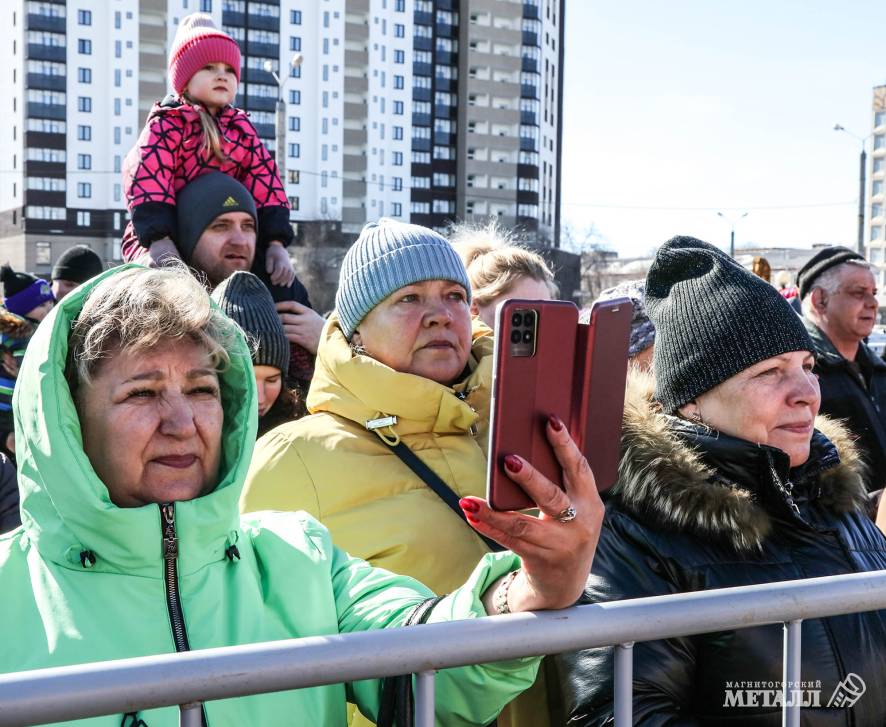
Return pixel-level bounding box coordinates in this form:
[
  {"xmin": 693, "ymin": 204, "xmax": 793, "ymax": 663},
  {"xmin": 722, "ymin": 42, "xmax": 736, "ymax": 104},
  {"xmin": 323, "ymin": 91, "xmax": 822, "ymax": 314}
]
[{"xmin": 335, "ymin": 217, "xmax": 471, "ymax": 340}]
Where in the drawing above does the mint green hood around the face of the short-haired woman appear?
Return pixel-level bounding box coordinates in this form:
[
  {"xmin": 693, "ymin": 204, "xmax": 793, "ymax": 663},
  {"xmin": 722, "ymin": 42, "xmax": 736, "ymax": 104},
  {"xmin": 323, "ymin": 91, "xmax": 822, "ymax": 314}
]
[{"xmin": 13, "ymin": 265, "xmax": 258, "ymax": 578}]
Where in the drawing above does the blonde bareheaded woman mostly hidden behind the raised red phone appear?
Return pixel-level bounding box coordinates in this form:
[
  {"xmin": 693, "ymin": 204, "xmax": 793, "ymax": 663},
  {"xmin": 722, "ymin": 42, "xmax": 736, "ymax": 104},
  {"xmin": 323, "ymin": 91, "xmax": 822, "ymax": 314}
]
[{"xmin": 449, "ymin": 221, "xmax": 558, "ymax": 329}]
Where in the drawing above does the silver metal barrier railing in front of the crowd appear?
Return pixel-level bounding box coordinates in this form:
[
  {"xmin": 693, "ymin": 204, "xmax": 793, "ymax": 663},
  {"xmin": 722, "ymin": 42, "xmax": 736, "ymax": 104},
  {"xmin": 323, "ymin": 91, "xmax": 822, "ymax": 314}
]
[{"xmin": 0, "ymin": 571, "xmax": 886, "ymax": 727}]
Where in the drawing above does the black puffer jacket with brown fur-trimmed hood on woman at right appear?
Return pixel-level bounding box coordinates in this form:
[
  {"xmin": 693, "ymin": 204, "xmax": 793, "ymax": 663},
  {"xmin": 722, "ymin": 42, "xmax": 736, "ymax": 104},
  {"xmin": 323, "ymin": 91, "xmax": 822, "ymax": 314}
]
[{"xmin": 557, "ymin": 381, "xmax": 886, "ymax": 727}]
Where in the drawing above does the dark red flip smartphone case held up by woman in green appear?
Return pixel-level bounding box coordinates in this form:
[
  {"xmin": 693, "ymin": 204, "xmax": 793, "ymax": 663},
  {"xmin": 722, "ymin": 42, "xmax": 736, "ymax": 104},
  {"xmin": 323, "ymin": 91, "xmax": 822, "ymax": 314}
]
[{"xmin": 487, "ymin": 298, "xmax": 633, "ymax": 510}]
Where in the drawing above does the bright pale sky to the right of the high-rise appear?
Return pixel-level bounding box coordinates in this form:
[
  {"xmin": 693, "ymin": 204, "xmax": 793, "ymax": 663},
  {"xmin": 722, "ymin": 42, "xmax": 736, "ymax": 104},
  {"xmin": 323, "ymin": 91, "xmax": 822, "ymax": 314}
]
[{"xmin": 563, "ymin": 0, "xmax": 886, "ymax": 257}]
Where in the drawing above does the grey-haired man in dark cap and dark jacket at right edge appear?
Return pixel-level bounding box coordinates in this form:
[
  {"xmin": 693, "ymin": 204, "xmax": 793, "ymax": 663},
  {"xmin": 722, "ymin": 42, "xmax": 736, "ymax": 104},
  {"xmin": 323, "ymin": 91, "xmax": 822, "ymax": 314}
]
[{"xmin": 797, "ymin": 247, "xmax": 886, "ymax": 491}]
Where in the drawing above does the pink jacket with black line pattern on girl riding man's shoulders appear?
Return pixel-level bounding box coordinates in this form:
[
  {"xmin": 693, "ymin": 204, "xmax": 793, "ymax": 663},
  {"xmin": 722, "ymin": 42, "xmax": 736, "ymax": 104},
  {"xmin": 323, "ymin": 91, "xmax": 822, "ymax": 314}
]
[{"xmin": 122, "ymin": 96, "xmax": 293, "ymax": 260}]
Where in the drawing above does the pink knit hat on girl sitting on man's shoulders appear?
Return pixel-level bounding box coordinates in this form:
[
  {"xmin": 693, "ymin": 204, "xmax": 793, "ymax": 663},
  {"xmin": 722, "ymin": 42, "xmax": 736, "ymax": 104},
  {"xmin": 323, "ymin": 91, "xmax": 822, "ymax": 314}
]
[{"xmin": 169, "ymin": 13, "xmax": 240, "ymax": 93}]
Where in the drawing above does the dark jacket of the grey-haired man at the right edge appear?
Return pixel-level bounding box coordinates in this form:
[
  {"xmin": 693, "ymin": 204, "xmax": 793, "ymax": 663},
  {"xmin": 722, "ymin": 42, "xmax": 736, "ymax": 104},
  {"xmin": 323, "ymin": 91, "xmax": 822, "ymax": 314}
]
[{"xmin": 806, "ymin": 321, "xmax": 886, "ymax": 491}]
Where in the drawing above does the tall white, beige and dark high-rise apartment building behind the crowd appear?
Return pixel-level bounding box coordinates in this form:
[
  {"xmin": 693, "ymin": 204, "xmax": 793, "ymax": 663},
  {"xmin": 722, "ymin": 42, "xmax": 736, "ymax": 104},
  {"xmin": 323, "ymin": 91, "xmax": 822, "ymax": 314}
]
[{"xmin": 0, "ymin": 0, "xmax": 565, "ymax": 273}]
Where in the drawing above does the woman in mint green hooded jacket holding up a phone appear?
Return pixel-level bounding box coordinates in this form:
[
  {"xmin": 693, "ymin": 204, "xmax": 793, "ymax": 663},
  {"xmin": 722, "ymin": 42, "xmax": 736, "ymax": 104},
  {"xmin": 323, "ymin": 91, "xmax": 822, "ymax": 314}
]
[{"xmin": 0, "ymin": 266, "xmax": 602, "ymax": 727}]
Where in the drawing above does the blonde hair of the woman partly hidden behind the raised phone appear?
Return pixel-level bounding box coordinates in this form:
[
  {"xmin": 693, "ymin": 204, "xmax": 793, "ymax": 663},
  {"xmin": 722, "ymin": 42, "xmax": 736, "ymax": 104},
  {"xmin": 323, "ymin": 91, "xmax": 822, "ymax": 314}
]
[{"xmin": 449, "ymin": 220, "xmax": 558, "ymax": 305}]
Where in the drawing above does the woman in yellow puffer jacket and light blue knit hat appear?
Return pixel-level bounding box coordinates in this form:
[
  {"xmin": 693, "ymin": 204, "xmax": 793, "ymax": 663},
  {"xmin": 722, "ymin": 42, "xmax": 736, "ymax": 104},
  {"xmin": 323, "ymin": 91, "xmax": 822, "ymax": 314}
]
[{"xmin": 241, "ymin": 219, "xmax": 560, "ymax": 727}]
